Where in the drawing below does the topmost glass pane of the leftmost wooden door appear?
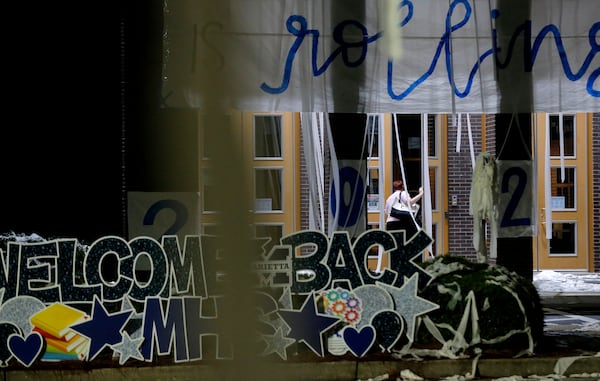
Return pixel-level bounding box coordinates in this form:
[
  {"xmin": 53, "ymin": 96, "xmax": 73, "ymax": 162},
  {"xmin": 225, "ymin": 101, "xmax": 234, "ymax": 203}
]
[{"xmin": 254, "ymin": 115, "xmax": 282, "ymax": 158}]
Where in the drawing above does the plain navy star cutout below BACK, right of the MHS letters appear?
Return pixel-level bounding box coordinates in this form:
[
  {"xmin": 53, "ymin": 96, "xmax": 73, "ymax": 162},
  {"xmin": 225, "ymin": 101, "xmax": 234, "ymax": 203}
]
[{"xmin": 278, "ymin": 293, "xmax": 340, "ymax": 356}]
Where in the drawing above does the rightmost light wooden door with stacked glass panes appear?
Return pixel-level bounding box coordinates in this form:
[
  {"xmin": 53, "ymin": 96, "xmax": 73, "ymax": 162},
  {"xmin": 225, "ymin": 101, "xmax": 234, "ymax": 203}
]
[{"xmin": 533, "ymin": 113, "xmax": 589, "ymax": 270}]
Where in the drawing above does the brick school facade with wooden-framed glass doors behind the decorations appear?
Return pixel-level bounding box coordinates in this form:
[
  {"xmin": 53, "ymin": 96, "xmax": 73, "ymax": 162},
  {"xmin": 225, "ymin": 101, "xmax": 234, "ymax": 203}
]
[{"xmin": 198, "ymin": 111, "xmax": 600, "ymax": 272}]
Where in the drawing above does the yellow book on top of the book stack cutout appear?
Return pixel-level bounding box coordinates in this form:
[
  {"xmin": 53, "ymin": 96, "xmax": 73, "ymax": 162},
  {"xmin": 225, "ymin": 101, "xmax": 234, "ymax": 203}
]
[{"xmin": 29, "ymin": 303, "xmax": 89, "ymax": 338}]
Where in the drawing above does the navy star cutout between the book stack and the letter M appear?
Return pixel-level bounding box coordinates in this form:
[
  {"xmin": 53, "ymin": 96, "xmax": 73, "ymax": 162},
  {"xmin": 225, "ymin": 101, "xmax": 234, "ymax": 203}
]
[{"xmin": 71, "ymin": 296, "xmax": 132, "ymax": 360}]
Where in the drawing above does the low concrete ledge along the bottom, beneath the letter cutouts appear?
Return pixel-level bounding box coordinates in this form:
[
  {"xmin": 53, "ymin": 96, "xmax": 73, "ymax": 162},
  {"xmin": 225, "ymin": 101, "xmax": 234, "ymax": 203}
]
[{"xmin": 4, "ymin": 356, "xmax": 600, "ymax": 381}]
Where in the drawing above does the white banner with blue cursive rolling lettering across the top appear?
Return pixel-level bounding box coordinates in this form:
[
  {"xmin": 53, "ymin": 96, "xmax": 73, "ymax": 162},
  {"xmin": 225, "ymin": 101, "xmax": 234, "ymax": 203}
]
[{"xmin": 162, "ymin": 0, "xmax": 600, "ymax": 113}]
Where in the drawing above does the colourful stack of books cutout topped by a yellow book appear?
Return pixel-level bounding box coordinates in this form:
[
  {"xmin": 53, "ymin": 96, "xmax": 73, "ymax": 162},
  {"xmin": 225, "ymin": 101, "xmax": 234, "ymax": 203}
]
[{"xmin": 30, "ymin": 303, "xmax": 90, "ymax": 361}]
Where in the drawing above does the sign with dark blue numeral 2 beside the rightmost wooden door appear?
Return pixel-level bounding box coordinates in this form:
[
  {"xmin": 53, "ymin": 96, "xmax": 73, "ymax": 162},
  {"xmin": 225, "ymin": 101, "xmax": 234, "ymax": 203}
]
[{"xmin": 497, "ymin": 160, "xmax": 536, "ymax": 237}]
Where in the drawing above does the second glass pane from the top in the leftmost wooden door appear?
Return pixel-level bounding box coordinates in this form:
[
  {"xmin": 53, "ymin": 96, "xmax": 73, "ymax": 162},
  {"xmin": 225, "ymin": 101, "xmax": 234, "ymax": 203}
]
[{"xmin": 254, "ymin": 168, "xmax": 283, "ymax": 213}]
